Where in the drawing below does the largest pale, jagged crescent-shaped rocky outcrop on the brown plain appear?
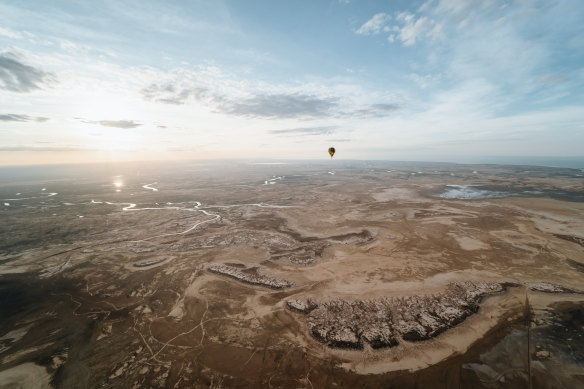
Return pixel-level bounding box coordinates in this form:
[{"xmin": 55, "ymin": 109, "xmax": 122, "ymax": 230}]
[{"xmin": 287, "ymin": 282, "xmax": 505, "ymax": 349}]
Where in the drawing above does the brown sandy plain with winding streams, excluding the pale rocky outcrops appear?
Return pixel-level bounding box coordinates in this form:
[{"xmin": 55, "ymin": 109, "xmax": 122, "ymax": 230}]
[{"xmin": 0, "ymin": 160, "xmax": 584, "ymax": 388}]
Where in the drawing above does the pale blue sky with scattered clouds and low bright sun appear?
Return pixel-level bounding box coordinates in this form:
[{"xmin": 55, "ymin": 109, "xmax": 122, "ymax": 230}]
[{"xmin": 0, "ymin": 0, "xmax": 584, "ymax": 165}]
